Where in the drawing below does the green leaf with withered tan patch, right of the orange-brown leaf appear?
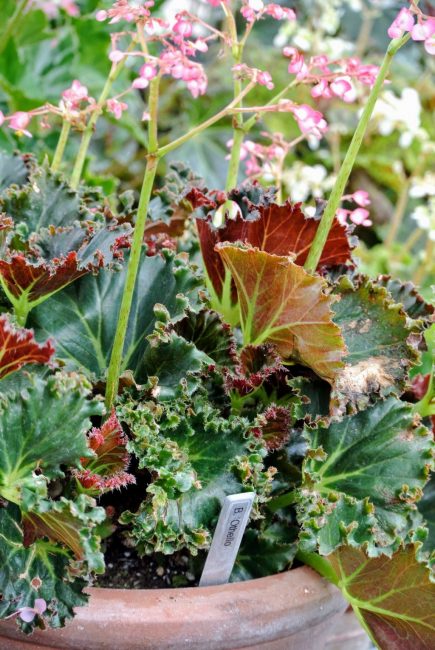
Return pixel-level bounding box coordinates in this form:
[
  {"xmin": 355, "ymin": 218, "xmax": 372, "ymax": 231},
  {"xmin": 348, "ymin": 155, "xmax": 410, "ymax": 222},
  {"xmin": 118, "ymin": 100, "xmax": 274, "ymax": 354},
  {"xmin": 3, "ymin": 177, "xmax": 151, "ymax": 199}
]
[{"xmin": 332, "ymin": 278, "xmax": 420, "ymax": 413}]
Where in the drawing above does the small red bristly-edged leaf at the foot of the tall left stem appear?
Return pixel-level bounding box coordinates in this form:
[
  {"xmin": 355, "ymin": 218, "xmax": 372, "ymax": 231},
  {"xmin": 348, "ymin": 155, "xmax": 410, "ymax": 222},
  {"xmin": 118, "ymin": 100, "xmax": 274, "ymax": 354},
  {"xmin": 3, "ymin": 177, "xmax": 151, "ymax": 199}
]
[{"xmin": 74, "ymin": 411, "xmax": 135, "ymax": 492}]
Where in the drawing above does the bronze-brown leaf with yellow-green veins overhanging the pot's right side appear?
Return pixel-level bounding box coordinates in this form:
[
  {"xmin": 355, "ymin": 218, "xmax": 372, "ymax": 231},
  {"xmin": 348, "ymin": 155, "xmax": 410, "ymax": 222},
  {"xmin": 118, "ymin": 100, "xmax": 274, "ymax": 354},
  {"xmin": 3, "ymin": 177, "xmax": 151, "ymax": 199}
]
[{"xmin": 328, "ymin": 546, "xmax": 435, "ymax": 650}]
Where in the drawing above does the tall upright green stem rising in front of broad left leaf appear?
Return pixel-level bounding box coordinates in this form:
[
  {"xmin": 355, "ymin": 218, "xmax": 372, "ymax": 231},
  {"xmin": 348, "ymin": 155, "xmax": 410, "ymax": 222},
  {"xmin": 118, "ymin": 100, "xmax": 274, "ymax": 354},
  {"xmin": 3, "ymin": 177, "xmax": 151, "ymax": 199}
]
[{"xmin": 106, "ymin": 77, "xmax": 160, "ymax": 409}]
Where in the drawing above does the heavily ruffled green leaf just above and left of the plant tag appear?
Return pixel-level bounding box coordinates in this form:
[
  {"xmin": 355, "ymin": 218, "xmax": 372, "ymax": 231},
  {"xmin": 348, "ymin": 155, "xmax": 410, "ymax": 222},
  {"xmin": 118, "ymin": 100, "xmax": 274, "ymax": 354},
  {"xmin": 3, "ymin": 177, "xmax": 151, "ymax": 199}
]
[{"xmin": 121, "ymin": 392, "xmax": 272, "ymax": 554}]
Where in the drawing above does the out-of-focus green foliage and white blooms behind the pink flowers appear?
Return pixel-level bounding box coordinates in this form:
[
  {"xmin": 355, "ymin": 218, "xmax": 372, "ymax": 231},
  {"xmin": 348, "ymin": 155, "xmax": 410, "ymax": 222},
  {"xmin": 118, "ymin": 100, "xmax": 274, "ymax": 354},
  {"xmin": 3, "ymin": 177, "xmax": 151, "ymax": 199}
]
[{"xmin": 0, "ymin": 0, "xmax": 435, "ymax": 299}]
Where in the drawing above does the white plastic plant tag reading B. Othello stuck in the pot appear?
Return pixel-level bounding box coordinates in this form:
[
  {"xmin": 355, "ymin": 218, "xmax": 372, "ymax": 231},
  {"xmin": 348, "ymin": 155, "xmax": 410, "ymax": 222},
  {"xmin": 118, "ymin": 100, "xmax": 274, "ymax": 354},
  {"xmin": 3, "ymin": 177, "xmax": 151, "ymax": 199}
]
[{"xmin": 199, "ymin": 492, "xmax": 255, "ymax": 587}]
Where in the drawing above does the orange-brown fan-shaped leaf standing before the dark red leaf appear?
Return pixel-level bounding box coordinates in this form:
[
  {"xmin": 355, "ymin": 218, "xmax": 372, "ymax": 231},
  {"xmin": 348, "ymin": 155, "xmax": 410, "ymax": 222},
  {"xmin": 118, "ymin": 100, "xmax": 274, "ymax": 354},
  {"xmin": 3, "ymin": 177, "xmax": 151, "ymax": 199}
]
[{"xmin": 217, "ymin": 244, "xmax": 345, "ymax": 381}]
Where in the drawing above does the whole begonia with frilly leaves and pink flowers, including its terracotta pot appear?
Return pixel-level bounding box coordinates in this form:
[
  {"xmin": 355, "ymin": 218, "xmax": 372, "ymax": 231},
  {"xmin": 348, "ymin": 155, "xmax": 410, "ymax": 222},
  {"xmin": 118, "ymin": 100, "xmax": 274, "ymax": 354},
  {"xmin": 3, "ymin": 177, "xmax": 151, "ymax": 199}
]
[{"xmin": 0, "ymin": 0, "xmax": 435, "ymax": 649}]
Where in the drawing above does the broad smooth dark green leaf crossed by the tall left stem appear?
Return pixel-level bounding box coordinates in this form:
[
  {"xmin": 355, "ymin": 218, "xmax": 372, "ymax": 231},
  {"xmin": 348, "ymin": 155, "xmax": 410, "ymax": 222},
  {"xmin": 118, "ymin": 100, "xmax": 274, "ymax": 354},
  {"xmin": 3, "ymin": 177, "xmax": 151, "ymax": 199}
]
[{"xmin": 31, "ymin": 249, "xmax": 204, "ymax": 377}]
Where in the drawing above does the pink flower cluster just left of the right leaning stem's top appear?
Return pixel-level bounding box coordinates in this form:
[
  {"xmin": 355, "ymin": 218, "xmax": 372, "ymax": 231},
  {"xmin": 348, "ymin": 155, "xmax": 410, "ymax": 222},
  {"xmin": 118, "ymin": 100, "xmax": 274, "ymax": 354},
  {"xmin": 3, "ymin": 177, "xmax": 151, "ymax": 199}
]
[{"xmin": 283, "ymin": 47, "xmax": 379, "ymax": 103}]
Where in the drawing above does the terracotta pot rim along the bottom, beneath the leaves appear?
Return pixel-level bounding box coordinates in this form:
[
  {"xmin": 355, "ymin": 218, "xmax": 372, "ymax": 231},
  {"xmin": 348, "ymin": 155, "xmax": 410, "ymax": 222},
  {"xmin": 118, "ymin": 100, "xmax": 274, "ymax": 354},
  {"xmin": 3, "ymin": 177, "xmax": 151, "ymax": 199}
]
[{"xmin": 0, "ymin": 567, "xmax": 347, "ymax": 650}]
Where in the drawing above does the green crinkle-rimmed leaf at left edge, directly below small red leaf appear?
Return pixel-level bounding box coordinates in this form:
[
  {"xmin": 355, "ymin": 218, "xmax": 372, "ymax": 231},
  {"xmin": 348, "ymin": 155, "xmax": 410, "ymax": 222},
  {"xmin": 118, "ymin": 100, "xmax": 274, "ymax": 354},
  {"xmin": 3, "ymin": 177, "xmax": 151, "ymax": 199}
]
[{"xmin": 0, "ymin": 374, "xmax": 102, "ymax": 507}]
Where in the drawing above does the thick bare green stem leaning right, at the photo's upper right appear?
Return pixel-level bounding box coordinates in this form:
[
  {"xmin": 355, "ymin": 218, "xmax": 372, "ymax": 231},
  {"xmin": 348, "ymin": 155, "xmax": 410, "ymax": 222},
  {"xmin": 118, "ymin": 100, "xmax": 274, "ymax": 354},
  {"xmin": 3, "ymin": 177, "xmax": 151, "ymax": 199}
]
[{"xmin": 304, "ymin": 34, "xmax": 410, "ymax": 271}]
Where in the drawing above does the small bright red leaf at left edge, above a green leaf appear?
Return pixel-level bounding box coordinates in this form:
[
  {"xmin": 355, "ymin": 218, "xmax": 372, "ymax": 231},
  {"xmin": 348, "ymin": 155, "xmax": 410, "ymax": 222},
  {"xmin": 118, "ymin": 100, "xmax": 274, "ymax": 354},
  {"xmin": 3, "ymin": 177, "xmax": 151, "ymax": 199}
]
[{"xmin": 0, "ymin": 314, "xmax": 54, "ymax": 379}]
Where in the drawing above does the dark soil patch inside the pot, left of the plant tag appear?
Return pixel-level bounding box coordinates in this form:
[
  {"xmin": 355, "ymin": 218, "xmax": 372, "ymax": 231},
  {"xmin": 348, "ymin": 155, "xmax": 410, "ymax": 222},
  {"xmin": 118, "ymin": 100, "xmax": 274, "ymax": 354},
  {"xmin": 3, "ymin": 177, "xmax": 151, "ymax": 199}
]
[{"xmin": 94, "ymin": 535, "xmax": 203, "ymax": 589}]
